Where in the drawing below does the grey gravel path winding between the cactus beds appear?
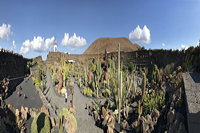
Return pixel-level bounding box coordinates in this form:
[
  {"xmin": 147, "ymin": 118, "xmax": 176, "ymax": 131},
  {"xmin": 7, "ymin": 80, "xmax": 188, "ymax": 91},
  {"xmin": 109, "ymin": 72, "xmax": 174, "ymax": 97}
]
[{"xmin": 46, "ymin": 69, "xmax": 103, "ymax": 133}]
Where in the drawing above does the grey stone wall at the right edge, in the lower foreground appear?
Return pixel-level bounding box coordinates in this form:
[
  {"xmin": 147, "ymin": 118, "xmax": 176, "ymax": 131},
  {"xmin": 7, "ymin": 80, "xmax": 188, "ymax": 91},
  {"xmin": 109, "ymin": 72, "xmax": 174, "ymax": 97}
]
[{"xmin": 183, "ymin": 72, "xmax": 200, "ymax": 133}]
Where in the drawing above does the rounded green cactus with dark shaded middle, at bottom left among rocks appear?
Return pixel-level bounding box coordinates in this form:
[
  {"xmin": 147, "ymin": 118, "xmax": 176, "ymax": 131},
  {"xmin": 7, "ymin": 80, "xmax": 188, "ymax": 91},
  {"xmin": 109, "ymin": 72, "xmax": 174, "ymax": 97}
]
[{"xmin": 31, "ymin": 112, "xmax": 51, "ymax": 133}]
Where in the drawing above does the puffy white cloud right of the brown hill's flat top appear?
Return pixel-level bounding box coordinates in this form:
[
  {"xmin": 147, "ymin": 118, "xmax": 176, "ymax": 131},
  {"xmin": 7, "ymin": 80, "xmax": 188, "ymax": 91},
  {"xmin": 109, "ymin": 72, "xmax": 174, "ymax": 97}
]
[{"xmin": 129, "ymin": 25, "xmax": 151, "ymax": 44}]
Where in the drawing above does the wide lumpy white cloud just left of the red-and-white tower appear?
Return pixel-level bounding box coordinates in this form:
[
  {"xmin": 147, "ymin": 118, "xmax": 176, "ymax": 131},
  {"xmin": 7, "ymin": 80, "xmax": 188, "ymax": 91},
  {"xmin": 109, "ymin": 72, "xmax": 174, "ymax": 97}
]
[{"xmin": 20, "ymin": 36, "xmax": 55, "ymax": 54}]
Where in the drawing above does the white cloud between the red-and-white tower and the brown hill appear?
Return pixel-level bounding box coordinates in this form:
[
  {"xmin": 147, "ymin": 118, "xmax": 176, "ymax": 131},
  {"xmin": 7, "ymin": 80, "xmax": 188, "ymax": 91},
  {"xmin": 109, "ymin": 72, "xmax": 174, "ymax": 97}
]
[{"xmin": 61, "ymin": 33, "xmax": 87, "ymax": 47}]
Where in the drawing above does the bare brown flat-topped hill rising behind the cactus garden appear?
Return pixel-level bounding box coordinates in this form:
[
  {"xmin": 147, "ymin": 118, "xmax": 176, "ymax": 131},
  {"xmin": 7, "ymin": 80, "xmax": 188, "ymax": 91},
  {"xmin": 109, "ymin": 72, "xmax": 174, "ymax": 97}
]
[{"xmin": 83, "ymin": 37, "xmax": 141, "ymax": 54}]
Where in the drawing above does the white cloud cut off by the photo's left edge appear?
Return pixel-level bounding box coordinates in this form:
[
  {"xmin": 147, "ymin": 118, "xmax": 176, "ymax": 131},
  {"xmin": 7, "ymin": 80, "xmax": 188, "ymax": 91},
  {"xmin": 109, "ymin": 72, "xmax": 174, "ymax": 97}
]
[{"xmin": 0, "ymin": 24, "xmax": 12, "ymax": 40}]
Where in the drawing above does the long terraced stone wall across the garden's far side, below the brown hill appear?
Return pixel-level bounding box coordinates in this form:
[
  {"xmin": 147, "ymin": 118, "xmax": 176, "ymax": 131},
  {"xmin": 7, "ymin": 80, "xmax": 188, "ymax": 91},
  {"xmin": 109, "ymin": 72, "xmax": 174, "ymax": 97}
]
[{"xmin": 46, "ymin": 50, "xmax": 184, "ymax": 68}]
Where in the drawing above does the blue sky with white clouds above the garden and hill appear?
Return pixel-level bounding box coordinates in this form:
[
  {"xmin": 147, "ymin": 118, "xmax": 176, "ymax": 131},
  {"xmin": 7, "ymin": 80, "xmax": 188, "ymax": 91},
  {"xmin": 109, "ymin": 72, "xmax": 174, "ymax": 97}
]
[{"xmin": 0, "ymin": 0, "xmax": 200, "ymax": 59}]
